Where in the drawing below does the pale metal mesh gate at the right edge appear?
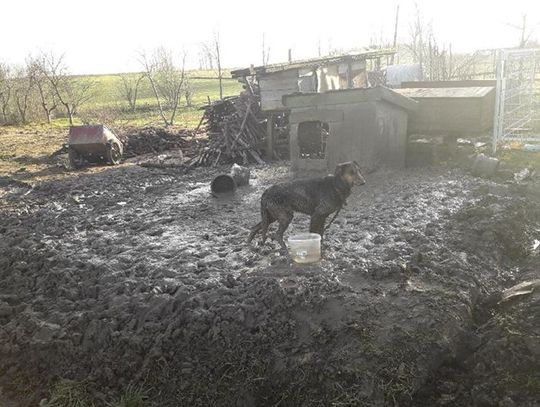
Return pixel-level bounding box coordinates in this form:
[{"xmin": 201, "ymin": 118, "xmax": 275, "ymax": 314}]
[{"xmin": 493, "ymin": 49, "xmax": 540, "ymax": 152}]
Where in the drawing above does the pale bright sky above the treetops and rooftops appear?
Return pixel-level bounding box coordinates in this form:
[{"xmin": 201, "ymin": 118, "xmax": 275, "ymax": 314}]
[{"xmin": 0, "ymin": 0, "xmax": 540, "ymax": 74}]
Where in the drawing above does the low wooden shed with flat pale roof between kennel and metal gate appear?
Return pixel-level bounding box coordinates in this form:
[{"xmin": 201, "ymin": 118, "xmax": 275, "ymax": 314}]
[{"xmin": 396, "ymin": 86, "xmax": 495, "ymax": 137}]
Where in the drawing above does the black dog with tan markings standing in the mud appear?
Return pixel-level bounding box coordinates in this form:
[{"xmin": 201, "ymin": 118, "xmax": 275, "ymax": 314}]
[{"xmin": 248, "ymin": 161, "xmax": 366, "ymax": 250}]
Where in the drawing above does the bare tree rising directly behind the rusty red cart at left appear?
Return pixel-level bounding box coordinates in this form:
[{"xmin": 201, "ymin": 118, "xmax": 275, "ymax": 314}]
[{"xmin": 42, "ymin": 53, "xmax": 94, "ymax": 125}]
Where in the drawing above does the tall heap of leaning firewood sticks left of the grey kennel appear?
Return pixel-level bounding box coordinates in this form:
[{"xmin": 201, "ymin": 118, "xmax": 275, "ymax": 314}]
[{"xmin": 190, "ymin": 88, "xmax": 265, "ymax": 166}]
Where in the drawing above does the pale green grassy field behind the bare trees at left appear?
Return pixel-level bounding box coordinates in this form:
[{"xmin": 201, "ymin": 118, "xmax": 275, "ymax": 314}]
[{"xmin": 0, "ymin": 70, "xmax": 242, "ymax": 130}]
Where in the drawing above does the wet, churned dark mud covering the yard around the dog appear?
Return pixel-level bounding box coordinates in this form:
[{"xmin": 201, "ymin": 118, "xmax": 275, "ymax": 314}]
[{"xmin": 0, "ymin": 164, "xmax": 540, "ymax": 406}]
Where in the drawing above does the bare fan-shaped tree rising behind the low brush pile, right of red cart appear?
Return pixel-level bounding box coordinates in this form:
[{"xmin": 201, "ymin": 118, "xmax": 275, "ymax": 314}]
[{"xmin": 140, "ymin": 48, "xmax": 186, "ymax": 126}]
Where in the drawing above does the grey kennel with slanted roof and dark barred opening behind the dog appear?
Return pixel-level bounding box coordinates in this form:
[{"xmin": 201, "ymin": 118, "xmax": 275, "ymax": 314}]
[{"xmin": 283, "ymin": 87, "xmax": 417, "ymax": 171}]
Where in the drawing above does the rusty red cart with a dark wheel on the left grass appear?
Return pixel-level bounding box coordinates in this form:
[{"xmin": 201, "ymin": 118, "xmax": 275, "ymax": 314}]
[{"xmin": 68, "ymin": 125, "xmax": 124, "ymax": 168}]
